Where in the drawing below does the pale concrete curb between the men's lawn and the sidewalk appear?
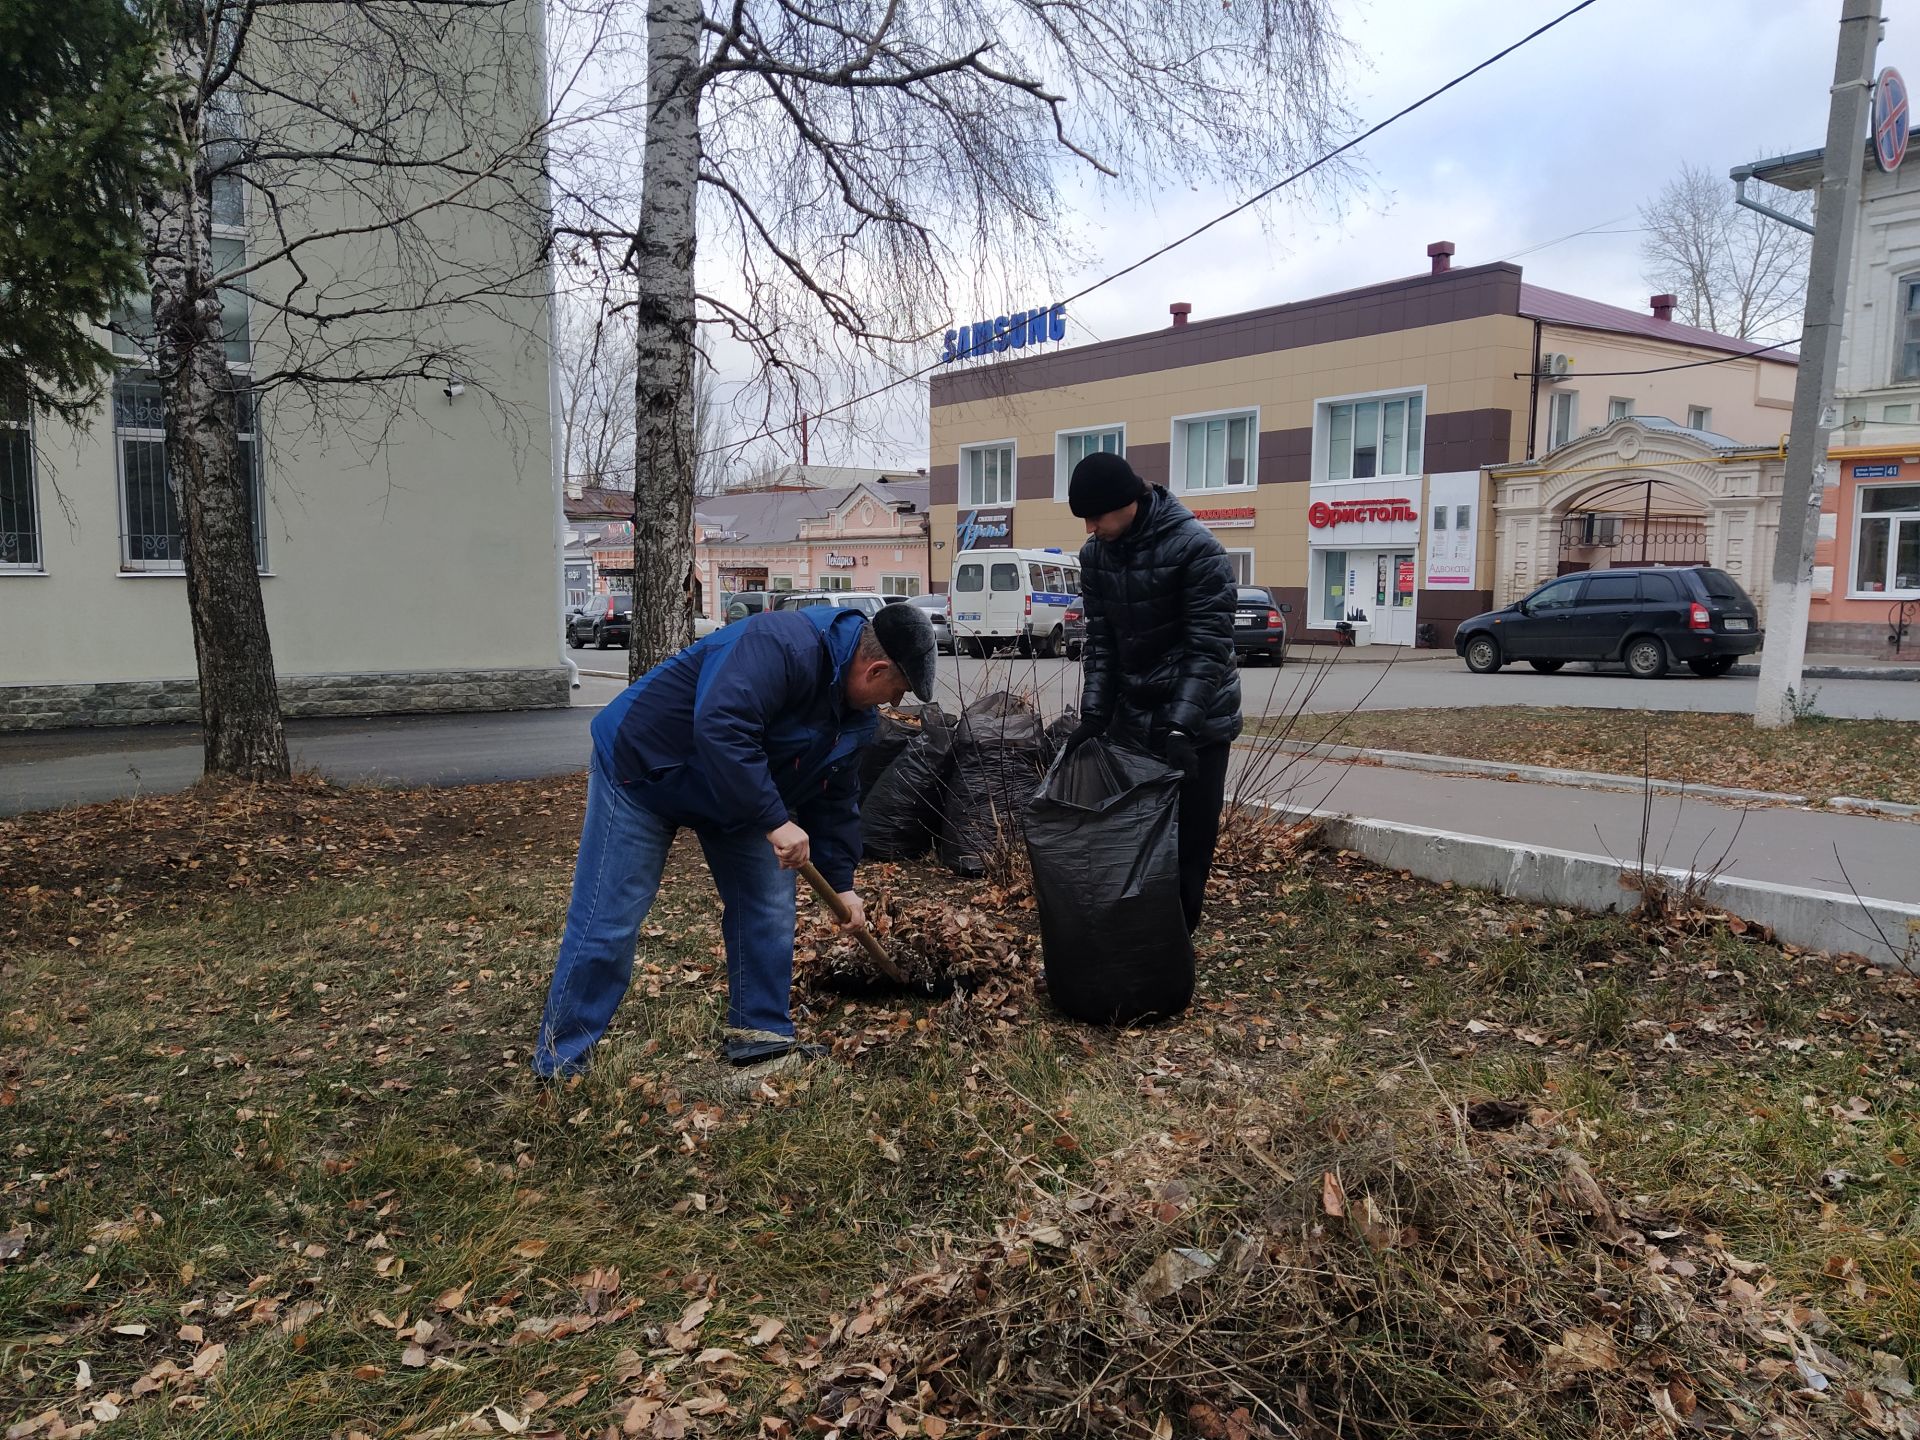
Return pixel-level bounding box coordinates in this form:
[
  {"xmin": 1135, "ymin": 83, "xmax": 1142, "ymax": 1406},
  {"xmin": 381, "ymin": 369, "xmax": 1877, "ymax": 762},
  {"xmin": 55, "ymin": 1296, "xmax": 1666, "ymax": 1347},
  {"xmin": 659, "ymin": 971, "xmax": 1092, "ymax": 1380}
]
[{"xmin": 1265, "ymin": 803, "xmax": 1920, "ymax": 973}]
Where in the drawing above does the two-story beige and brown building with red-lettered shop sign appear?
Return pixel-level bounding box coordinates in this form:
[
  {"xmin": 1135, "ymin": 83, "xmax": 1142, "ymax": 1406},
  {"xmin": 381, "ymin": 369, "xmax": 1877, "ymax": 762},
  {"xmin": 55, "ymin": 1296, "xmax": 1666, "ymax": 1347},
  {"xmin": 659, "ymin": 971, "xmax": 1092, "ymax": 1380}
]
[{"xmin": 929, "ymin": 242, "xmax": 1791, "ymax": 645}]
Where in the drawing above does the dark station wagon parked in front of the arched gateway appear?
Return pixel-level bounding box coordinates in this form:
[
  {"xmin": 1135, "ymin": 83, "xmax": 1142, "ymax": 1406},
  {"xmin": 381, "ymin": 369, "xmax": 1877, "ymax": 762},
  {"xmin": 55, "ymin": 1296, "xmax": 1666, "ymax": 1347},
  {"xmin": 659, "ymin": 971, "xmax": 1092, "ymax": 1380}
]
[{"xmin": 1453, "ymin": 564, "xmax": 1764, "ymax": 680}]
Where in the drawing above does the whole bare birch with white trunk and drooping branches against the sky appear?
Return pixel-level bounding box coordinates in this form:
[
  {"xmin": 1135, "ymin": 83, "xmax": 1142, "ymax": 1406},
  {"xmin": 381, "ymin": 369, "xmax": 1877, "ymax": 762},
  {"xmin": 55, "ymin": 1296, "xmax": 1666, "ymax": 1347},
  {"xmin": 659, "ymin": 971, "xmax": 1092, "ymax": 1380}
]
[{"xmin": 561, "ymin": 0, "xmax": 1344, "ymax": 674}]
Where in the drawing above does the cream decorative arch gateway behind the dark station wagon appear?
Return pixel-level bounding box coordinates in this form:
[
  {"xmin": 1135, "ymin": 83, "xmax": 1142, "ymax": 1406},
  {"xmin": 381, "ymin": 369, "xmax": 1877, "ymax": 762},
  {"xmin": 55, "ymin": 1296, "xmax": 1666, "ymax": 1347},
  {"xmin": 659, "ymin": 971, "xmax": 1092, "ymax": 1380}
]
[{"xmin": 1486, "ymin": 417, "xmax": 1786, "ymax": 618}]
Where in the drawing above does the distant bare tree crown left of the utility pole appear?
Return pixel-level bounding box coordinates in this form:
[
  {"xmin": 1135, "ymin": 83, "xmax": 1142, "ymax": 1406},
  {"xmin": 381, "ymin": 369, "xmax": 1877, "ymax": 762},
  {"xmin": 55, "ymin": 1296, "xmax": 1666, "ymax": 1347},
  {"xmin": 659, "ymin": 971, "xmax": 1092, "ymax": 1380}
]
[{"xmin": 1640, "ymin": 165, "xmax": 1812, "ymax": 340}]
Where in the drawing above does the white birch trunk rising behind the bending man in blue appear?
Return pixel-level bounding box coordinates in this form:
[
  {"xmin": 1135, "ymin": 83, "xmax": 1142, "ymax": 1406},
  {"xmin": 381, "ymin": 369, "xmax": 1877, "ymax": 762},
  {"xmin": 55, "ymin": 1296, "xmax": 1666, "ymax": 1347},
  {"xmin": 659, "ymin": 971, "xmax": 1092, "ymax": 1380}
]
[{"xmin": 628, "ymin": 0, "xmax": 701, "ymax": 678}]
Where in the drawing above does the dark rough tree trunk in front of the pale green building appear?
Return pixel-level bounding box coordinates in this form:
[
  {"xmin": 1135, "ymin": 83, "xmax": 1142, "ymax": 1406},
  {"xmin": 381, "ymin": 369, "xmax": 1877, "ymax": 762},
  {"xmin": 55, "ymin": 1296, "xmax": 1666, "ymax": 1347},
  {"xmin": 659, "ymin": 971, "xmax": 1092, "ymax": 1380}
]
[{"xmin": 140, "ymin": 19, "xmax": 290, "ymax": 780}]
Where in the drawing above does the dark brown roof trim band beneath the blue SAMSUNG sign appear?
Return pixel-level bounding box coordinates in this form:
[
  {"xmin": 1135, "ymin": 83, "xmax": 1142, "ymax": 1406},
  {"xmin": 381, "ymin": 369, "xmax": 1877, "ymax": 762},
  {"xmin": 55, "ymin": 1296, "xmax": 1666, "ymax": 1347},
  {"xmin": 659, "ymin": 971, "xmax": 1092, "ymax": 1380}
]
[{"xmin": 927, "ymin": 261, "xmax": 1521, "ymax": 405}]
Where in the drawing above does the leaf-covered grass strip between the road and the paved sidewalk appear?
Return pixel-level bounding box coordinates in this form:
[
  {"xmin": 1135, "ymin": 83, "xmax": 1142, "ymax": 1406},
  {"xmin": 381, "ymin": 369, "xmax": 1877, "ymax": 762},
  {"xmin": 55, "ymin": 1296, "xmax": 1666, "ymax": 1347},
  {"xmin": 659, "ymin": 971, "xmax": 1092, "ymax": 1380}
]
[{"xmin": 1288, "ymin": 705, "xmax": 1920, "ymax": 804}]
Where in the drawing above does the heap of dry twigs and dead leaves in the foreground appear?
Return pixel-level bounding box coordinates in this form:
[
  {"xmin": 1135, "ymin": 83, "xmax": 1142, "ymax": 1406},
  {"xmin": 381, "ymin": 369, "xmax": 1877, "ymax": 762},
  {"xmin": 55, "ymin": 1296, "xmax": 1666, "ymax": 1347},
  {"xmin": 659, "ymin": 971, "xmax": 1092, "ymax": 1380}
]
[{"xmin": 816, "ymin": 1104, "xmax": 1920, "ymax": 1440}]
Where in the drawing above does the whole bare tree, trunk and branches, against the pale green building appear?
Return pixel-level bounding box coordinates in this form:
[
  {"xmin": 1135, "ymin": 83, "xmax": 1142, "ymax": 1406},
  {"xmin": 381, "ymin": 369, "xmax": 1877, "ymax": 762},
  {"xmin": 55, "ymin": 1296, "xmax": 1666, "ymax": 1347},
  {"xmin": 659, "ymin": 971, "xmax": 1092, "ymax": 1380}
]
[{"xmin": 117, "ymin": 0, "xmax": 549, "ymax": 780}]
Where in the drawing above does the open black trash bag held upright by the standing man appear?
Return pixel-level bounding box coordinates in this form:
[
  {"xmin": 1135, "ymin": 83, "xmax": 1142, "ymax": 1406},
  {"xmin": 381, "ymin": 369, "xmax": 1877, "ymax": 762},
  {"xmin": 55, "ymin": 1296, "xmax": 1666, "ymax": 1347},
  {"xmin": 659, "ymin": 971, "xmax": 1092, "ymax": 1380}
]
[{"xmin": 1025, "ymin": 739, "xmax": 1194, "ymax": 1025}]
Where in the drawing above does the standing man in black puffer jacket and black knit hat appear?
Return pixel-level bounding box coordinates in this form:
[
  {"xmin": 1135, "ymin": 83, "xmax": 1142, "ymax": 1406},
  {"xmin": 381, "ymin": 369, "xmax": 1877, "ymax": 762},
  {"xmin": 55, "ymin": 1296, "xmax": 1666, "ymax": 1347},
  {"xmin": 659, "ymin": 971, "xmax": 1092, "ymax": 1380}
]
[{"xmin": 1068, "ymin": 451, "xmax": 1240, "ymax": 933}]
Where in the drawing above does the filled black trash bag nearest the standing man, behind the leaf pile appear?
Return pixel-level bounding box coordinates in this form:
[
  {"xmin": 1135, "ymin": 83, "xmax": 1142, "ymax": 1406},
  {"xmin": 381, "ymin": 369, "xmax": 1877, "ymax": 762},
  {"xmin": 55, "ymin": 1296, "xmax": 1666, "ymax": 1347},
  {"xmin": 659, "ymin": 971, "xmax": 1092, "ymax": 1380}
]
[{"xmin": 941, "ymin": 689, "xmax": 1046, "ymax": 877}]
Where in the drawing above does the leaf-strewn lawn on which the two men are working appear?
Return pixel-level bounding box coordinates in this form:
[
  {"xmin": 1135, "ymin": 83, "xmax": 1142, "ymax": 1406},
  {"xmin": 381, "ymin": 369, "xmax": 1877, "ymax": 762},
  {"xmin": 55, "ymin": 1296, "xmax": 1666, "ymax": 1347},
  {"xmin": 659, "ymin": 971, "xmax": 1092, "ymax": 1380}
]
[{"xmin": 0, "ymin": 783, "xmax": 1920, "ymax": 1440}]
